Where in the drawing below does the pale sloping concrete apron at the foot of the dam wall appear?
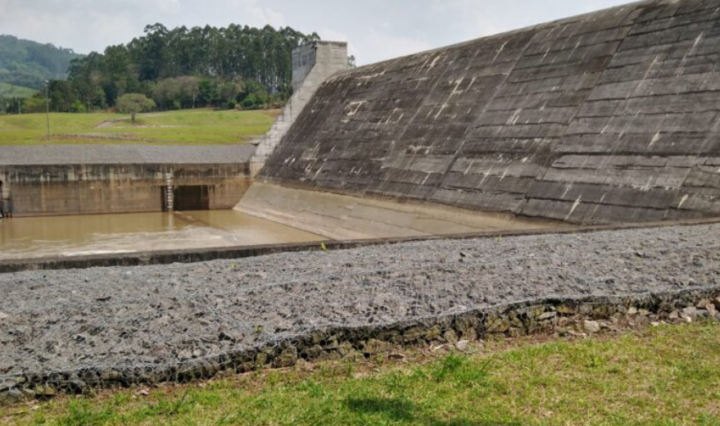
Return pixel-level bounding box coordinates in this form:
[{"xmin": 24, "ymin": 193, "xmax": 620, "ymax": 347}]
[{"xmin": 235, "ymin": 182, "xmax": 556, "ymax": 240}]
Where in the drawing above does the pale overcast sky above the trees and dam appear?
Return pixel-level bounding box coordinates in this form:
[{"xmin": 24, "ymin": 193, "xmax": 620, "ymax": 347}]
[{"xmin": 0, "ymin": 0, "xmax": 629, "ymax": 65}]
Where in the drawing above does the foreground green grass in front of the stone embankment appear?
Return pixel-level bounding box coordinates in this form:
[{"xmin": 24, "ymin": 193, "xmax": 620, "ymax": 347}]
[{"xmin": 0, "ymin": 324, "xmax": 720, "ymax": 426}]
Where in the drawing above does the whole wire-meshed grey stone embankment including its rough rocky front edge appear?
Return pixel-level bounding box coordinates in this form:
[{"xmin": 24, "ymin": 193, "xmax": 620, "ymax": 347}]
[{"xmin": 0, "ymin": 225, "xmax": 720, "ymax": 402}]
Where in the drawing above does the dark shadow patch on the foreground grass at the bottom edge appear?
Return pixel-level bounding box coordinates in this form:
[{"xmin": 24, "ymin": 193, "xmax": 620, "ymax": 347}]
[{"xmin": 346, "ymin": 398, "xmax": 521, "ymax": 426}]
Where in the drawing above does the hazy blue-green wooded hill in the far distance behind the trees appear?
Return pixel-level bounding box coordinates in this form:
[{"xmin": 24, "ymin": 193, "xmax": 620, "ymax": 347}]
[{"xmin": 0, "ymin": 35, "xmax": 81, "ymax": 89}]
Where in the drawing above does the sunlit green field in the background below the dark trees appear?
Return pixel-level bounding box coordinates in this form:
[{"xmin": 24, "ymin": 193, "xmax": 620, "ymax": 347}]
[{"xmin": 0, "ymin": 109, "xmax": 278, "ymax": 145}]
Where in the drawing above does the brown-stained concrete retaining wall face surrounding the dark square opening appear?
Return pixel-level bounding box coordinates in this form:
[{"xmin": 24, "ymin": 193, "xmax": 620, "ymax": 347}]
[{"xmin": 0, "ymin": 164, "xmax": 250, "ymax": 217}]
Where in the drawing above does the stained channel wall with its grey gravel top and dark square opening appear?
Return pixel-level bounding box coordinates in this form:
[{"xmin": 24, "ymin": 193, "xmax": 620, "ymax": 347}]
[{"xmin": 0, "ymin": 146, "xmax": 252, "ymax": 217}]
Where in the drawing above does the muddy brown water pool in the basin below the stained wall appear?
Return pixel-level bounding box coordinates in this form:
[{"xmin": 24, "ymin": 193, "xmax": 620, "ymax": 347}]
[{"xmin": 0, "ymin": 210, "xmax": 326, "ymax": 260}]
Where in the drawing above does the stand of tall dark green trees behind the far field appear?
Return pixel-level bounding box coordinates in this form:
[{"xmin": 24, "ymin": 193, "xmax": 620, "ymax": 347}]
[{"xmin": 0, "ymin": 24, "xmax": 320, "ymax": 113}]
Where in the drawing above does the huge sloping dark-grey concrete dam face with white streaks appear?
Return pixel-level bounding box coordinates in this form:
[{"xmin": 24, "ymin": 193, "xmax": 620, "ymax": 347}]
[{"xmin": 260, "ymin": 0, "xmax": 720, "ymax": 223}]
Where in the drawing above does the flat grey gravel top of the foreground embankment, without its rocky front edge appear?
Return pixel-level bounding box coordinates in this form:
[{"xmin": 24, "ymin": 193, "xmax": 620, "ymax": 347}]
[{"xmin": 0, "ymin": 225, "xmax": 720, "ymax": 382}]
